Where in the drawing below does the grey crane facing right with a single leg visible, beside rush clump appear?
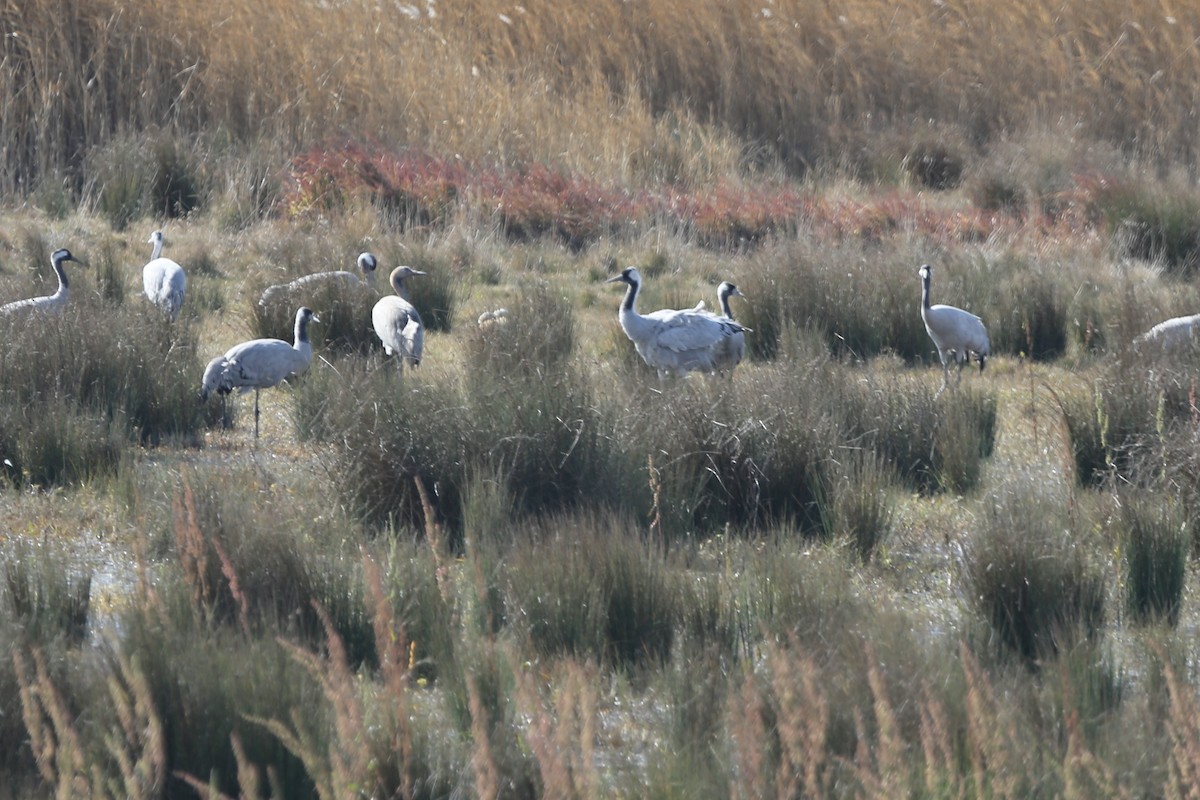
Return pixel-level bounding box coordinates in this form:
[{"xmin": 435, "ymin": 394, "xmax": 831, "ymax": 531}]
[{"xmin": 200, "ymin": 307, "xmax": 320, "ymax": 439}]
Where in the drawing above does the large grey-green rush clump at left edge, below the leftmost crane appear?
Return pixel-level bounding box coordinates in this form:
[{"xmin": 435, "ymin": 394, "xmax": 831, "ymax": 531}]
[{"xmin": 0, "ymin": 301, "xmax": 209, "ymax": 483}]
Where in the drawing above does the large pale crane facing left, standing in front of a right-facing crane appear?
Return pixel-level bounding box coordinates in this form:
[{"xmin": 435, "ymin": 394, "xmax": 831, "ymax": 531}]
[{"xmin": 607, "ymin": 266, "xmax": 749, "ymax": 379}]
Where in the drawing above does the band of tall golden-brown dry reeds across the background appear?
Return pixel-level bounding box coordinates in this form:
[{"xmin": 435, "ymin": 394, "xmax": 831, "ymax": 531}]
[{"xmin": 7, "ymin": 0, "xmax": 1200, "ymax": 192}]
